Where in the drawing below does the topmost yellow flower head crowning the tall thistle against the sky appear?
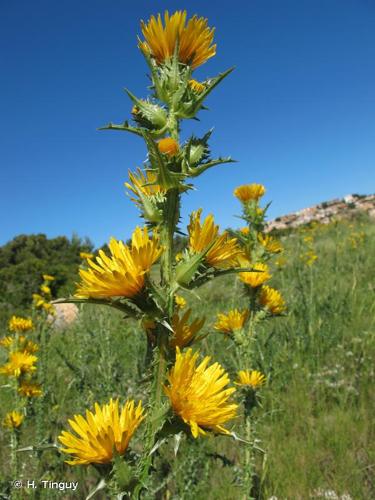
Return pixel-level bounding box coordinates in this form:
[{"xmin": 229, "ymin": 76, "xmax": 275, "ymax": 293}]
[{"xmin": 139, "ymin": 10, "xmax": 216, "ymax": 69}]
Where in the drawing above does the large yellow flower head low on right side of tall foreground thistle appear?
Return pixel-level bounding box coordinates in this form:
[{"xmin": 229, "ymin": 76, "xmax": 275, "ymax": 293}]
[{"xmin": 164, "ymin": 348, "xmax": 238, "ymax": 438}]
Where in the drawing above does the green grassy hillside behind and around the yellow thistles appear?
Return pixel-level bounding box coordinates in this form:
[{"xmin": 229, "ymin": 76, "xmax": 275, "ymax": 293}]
[{"xmin": 0, "ymin": 218, "xmax": 375, "ymax": 500}]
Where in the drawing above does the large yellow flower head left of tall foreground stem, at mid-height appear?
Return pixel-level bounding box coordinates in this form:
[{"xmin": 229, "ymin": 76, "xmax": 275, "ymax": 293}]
[{"xmin": 76, "ymin": 227, "xmax": 162, "ymax": 298}]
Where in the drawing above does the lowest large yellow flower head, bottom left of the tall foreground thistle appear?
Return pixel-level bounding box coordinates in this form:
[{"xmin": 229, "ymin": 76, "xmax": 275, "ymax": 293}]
[{"xmin": 58, "ymin": 399, "xmax": 145, "ymax": 465}]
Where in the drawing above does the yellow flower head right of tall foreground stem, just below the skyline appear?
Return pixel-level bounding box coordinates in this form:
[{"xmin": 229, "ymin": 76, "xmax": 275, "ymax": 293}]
[{"xmin": 188, "ymin": 209, "xmax": 242, "ymax": 268}]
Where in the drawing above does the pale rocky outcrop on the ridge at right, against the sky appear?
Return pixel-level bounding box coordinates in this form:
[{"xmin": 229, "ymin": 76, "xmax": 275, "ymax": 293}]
[{"xmin": 267, "ymin": 194, "xmax": 375, "ymax": 231}]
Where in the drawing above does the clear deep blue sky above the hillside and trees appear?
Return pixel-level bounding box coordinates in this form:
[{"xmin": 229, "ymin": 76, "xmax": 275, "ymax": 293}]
[{"xmin": 0, "ymin": 0, "xmax": 375, "ymax": 245}]
